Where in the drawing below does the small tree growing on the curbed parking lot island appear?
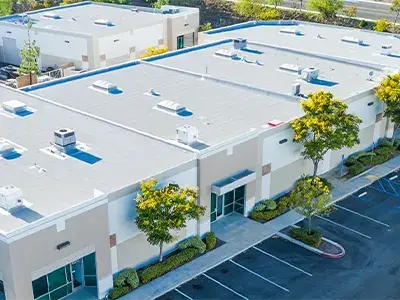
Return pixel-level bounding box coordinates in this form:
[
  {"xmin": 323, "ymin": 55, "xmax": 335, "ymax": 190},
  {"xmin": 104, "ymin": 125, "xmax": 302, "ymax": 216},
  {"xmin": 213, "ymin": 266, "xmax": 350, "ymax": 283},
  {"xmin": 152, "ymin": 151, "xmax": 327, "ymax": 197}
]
[{"xmin": 286, "ymin": 177, "xmax": 333, "ymax": 234}]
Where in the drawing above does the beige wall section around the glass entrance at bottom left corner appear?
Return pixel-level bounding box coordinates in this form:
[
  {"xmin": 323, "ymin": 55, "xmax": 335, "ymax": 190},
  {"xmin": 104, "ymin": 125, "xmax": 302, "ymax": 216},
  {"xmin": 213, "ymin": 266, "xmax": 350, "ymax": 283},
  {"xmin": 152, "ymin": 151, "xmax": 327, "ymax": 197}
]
[{"xmin": 5, "ymin": 204, "xmax": 111, "ymax": 300}]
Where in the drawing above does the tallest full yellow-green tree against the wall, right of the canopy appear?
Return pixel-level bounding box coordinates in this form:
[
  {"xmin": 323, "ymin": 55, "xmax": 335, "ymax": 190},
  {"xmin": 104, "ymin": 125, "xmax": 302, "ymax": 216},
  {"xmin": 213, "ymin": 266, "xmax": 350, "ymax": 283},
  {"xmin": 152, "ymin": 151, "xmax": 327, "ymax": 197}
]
[{"xmin": 291, "ymin": 91, "xmax": 362, "ymax": 178}]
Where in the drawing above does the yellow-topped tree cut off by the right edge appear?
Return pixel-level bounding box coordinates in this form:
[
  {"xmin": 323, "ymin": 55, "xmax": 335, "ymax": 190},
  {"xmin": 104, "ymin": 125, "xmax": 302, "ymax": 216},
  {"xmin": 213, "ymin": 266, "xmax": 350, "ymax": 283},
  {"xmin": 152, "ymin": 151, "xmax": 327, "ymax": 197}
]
[{"xmin": 376, "ymin": 73, "xmax": 400, "ymax": 143}]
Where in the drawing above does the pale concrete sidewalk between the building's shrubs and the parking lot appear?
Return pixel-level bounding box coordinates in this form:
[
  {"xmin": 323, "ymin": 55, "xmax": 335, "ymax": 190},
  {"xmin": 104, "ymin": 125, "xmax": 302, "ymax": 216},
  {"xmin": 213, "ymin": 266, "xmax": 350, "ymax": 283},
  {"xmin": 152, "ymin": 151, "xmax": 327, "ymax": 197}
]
[{"xmin": 120, "ymin": 156, "xmax": 400, "ymax": 300}]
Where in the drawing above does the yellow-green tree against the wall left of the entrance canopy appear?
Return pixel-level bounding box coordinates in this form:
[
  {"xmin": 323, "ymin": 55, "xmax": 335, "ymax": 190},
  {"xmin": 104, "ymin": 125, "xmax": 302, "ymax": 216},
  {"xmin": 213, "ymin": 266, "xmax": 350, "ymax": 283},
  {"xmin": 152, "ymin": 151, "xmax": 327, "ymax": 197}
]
[{"xmin": 136, "ymin": 179, "xmax": 205, "ymax": 262}]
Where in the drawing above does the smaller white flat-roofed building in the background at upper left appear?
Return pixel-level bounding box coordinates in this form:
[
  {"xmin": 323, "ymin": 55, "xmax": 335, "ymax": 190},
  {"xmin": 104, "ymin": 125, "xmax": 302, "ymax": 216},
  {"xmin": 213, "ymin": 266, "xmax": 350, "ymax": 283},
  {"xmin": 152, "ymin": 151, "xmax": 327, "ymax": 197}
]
[{"xmin": 0, "ymin": 2, "xmax": 199, "ymax": 70}]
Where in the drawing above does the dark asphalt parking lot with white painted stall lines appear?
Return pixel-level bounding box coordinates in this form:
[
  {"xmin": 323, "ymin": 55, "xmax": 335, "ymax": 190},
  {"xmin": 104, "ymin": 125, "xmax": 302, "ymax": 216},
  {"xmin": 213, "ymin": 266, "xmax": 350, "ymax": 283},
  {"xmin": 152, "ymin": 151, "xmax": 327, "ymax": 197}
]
[{"xmin": 158, "ymin": 172, "xmax": 400, "ymax": 300}]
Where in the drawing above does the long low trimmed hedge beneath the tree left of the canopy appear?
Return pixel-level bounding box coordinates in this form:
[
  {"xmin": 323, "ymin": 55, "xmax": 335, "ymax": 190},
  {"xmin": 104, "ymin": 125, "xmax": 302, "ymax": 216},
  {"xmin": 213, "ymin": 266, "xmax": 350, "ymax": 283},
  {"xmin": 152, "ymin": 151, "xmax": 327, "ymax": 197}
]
[{"xmin": 139, "ymin": 248, "xmax": 198, "ymax": 283}]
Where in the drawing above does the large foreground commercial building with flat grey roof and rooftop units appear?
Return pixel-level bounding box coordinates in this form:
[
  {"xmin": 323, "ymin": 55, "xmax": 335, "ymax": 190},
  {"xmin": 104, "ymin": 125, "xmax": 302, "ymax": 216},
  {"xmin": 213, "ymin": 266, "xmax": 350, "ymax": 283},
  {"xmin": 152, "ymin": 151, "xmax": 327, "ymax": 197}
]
[{"xmin": 0, "ymin": 19, "xmax": 396, "ymax": 300}]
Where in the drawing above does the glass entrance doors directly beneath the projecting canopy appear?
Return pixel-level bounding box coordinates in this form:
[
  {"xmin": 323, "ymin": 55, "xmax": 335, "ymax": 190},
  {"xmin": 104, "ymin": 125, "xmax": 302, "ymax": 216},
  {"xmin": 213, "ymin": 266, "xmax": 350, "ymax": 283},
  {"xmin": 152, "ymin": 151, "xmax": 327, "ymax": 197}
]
[{"xmin": 210, "ymin": 185, "xmax": 246, "ymax": 222}]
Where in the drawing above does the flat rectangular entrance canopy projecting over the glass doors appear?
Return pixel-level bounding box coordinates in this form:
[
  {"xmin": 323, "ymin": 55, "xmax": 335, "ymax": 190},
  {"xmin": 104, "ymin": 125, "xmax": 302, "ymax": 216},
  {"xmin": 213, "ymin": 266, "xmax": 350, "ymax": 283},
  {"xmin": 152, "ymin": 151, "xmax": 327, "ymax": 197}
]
[{"xmin": 211, "ymin": 169, "xmax": 256, "ymax": 196}]
